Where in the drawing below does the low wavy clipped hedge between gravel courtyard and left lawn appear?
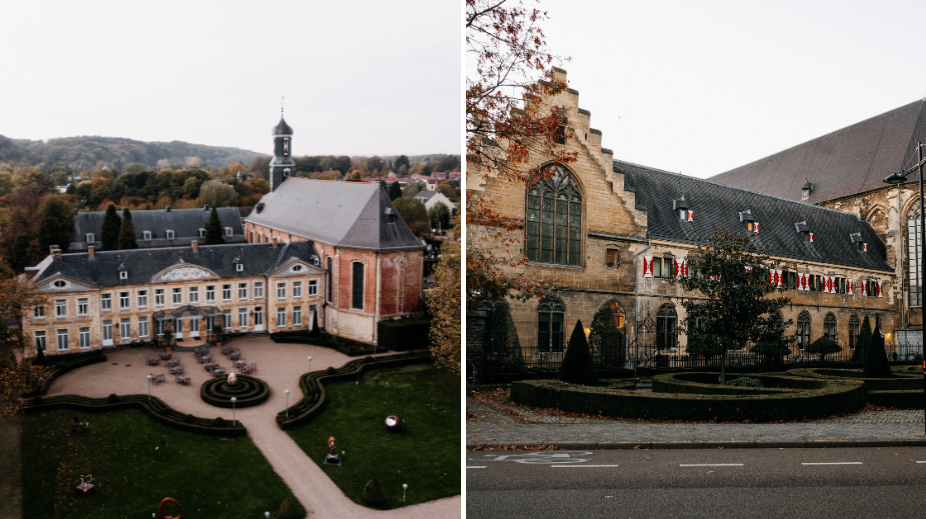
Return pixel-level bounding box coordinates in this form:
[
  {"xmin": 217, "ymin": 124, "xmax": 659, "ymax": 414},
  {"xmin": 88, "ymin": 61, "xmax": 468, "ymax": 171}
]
[{"xmin": 23, "ymin": 395, "xmax": 248, "ymax": 436}]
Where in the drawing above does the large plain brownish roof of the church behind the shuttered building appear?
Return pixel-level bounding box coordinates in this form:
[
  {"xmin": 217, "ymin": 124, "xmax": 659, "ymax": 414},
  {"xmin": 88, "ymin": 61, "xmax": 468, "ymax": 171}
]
[{"xmin": 710, "ymin": 100, "xmax": 926, "ymax": 204}]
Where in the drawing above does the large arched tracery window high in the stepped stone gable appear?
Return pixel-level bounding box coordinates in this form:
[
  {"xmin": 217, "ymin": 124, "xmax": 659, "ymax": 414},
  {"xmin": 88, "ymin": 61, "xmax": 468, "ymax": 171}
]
[{"xmin": 525, "ymin": 166, "xmax": 582, "ymax": 265}]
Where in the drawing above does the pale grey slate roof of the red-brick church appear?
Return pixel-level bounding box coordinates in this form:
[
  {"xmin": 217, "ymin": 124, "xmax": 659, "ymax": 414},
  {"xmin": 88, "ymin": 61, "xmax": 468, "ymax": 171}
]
[{"xmin": 245, "ymin": 177, "xmax": 424, "ymax": 250}]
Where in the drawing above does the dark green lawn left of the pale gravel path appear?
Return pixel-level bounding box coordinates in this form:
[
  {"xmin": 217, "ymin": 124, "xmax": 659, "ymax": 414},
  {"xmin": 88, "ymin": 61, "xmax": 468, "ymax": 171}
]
[{"xmin": 22, "ymin": 410, "xmax": 298, "ymax": 519}]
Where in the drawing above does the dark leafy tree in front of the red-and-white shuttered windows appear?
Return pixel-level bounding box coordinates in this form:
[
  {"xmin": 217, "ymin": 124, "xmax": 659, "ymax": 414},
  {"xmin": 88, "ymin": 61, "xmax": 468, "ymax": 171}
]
[{"xmin": 670, "ymin": 227, "xmax": 791, "ymax": 355}]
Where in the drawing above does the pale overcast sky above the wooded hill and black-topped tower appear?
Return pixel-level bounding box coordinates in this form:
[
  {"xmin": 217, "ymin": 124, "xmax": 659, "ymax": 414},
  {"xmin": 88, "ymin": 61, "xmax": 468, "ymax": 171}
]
[{"xmin": 0, "ymin": 0, "xmax": 463, "ymax": 155}]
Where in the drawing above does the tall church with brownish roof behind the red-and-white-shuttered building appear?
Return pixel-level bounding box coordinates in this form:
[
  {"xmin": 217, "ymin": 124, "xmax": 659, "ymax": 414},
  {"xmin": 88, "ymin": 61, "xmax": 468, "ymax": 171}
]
[{"xmin": 711, "ymin": 99, "xmax": 926, "ymax": 345}]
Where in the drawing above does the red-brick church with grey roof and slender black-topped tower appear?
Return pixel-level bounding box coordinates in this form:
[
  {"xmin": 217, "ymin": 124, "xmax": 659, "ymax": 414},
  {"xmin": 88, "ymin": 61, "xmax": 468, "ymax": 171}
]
[{"xmin": 244, "ymin": 112, "xmax": 425, "ymax": 343}]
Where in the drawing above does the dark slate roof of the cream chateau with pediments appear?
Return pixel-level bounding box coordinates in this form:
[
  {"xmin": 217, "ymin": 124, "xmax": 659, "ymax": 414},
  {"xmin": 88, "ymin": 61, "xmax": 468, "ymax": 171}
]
[{"xmin": 33, "ymin": 242, "xmax": 323, "ymax": 287}]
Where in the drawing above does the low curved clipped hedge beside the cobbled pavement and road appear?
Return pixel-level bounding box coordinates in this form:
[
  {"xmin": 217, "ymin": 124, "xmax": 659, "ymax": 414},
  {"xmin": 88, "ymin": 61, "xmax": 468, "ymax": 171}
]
[{"xmin": 511, "ymin": 373, "xmax": 865, "ymax": 422}]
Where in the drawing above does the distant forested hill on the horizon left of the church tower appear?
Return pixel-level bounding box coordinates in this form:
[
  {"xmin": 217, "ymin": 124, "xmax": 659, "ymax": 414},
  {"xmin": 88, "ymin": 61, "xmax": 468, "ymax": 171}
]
[{"xmin": 0, "ymin": 135, "xmax": 265, "ymax": 171}]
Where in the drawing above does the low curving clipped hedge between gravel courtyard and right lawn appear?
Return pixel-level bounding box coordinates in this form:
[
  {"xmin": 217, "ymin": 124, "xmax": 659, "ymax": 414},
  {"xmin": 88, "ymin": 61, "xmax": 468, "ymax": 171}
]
[{"xmin": 276, "ymin": 351, "xmax": 433, "ymax": 430}]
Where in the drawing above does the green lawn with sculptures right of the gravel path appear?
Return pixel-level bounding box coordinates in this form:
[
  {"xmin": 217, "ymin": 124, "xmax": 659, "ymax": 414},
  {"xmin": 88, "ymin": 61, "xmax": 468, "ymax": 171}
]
[{"xmin": 287, "ymin": 364, "xmax": 461, "ymax": 508}]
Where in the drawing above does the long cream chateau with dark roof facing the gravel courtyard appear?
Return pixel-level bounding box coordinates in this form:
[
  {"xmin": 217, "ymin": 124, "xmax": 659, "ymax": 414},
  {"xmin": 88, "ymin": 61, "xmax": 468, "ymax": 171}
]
[{"xmin": 23, "ymin": 240, "xmax": 326, "ymax": 356}]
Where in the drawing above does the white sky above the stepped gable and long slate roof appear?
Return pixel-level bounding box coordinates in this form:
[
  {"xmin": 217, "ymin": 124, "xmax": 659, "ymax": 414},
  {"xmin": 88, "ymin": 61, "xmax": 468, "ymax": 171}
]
[{"xmin": 525, "ymin": 0, "xmax": 926, "ymax": 177}]
